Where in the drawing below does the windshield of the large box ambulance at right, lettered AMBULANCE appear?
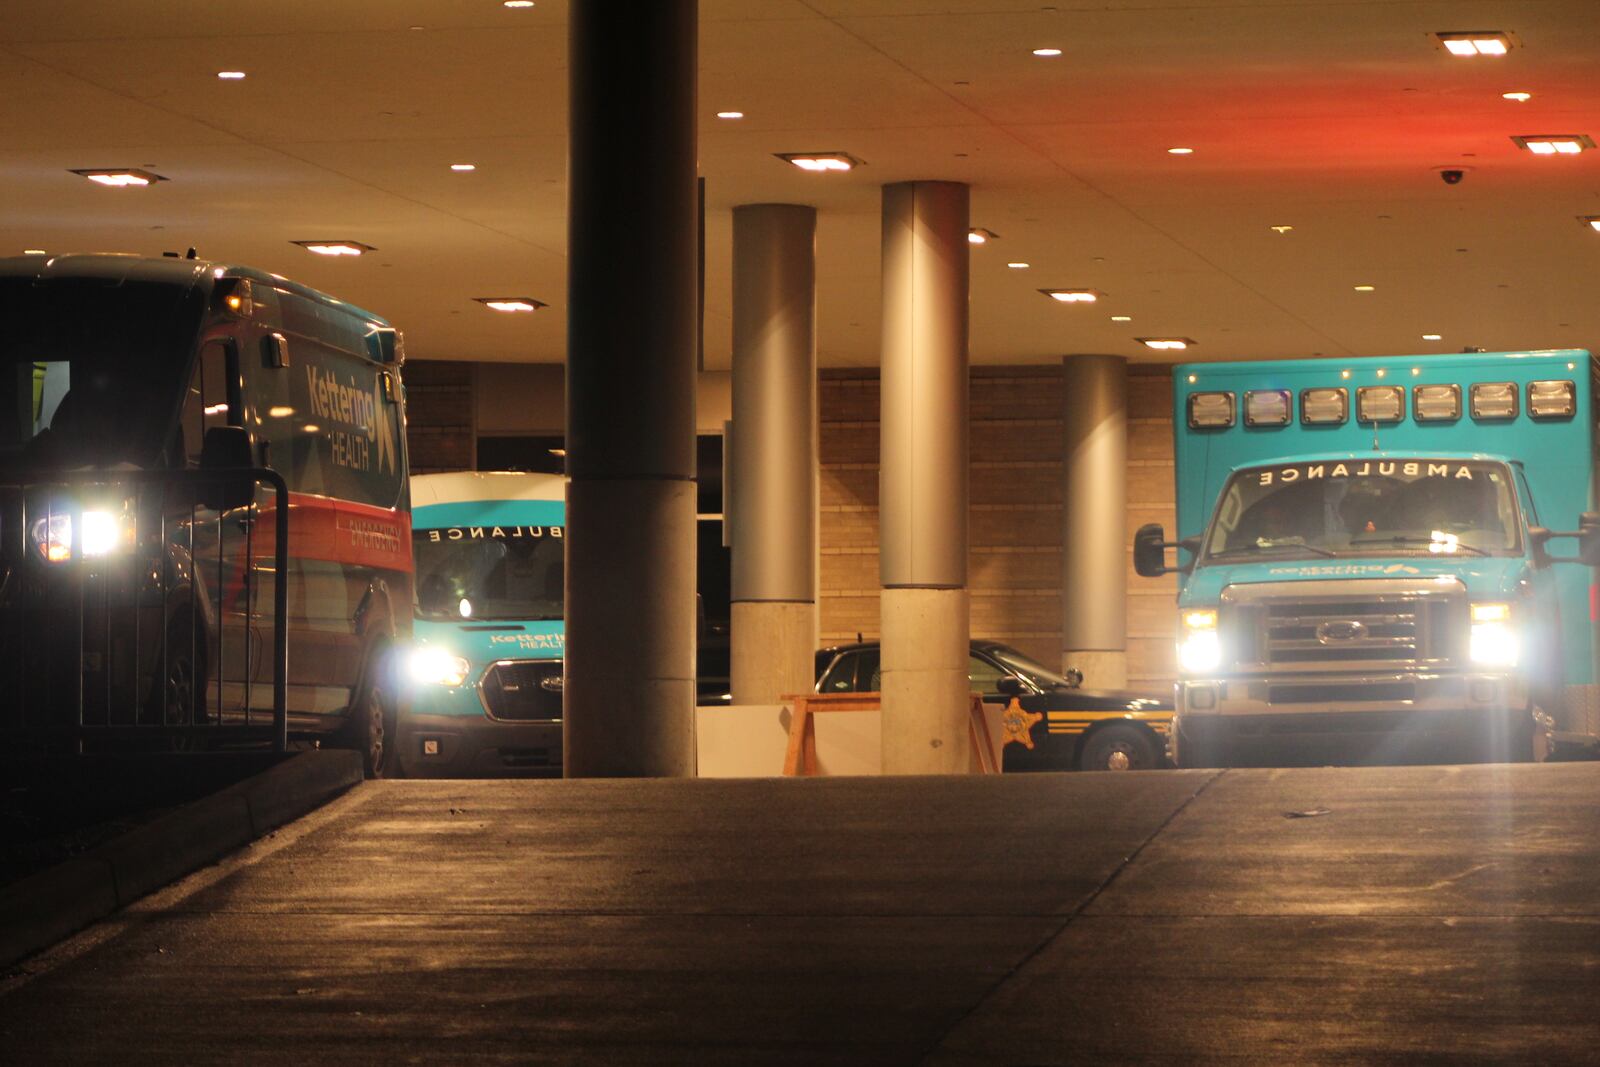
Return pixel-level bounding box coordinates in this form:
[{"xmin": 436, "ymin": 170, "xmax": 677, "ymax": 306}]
[{"xmin": 1200, "ymin": 456, "xmax": 1522, "ymax": 566}]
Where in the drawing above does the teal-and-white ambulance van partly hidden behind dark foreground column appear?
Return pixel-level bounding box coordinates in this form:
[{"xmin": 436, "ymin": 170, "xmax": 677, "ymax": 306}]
[{"xmin": 400, "ymin": 472, "xmax": 566, "ymax": 777}]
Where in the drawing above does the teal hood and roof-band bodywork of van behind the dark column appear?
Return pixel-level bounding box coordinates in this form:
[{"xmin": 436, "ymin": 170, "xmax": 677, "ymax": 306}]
[{"xmin": 411, "ymin": 501, "xmax": 566, "ymax": 717}]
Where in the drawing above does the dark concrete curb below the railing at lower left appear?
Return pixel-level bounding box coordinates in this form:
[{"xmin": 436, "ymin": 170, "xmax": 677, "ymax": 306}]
[{"xmin": 0, "ymin": 750, "xmax": 362, "ymax": 966}]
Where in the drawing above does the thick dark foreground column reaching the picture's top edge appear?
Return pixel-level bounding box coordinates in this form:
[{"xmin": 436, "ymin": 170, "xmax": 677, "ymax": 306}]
[{"xmin": 565, "ymin": 0, "xmax": 698, "ymax": 777}]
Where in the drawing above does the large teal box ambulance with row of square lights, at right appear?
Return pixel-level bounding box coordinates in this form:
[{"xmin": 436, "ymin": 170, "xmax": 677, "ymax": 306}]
[{"xmin": 1134, "ymin": 350, "xmax": 1600, "ymax": 766}]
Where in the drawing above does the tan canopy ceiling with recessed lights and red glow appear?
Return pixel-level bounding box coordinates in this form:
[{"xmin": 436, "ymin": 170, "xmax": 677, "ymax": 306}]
[{"xmin": 0, "ymin": 0, "xmax": 1600, "ymax": 368}]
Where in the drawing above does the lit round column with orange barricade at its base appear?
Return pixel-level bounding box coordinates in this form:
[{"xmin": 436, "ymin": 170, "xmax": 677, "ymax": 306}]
[{"xmin": 878, "ymin": 181, "xmax": 973, "ymax": 774}]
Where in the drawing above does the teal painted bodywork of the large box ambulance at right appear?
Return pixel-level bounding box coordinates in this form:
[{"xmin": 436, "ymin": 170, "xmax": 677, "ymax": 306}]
[{"xmin": 1173, "ymin": 349, "xmax": 1595, "ymax": 685}]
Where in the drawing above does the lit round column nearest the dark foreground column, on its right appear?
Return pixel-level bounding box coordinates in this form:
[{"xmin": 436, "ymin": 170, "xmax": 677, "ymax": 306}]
[{"xmin": 725, "ymin": 203, "xmax": 816, "ymax": 704}]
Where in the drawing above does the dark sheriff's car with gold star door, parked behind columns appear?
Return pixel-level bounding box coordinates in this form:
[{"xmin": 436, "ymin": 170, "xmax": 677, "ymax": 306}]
[{"xmin": 816, "ymin": 640, "xmax": 1173, "ymax": 771}]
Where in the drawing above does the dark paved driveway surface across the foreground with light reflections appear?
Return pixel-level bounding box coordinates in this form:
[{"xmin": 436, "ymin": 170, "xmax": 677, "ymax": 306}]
[{"xmin": 0, "ymin": 763, "xmax": 1600, "ymax": 1067}]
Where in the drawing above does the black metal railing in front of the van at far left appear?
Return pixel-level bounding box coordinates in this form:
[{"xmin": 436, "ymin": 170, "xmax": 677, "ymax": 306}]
[{"xmin": 0, "ymin": 467, "xmax": 290, "ymax": 755}]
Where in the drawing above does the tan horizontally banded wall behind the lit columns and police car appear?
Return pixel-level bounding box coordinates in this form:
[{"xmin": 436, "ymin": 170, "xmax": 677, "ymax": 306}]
[{"xmin": 818, "ymin": 366, "xmax": 1176, "ymax": 686}]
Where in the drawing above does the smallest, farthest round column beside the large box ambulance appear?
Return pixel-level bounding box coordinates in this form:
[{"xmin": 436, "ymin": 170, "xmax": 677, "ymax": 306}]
[{"xmin": 1061, "ymin": 355, "xmax": 1128, "ymax": 689}]
